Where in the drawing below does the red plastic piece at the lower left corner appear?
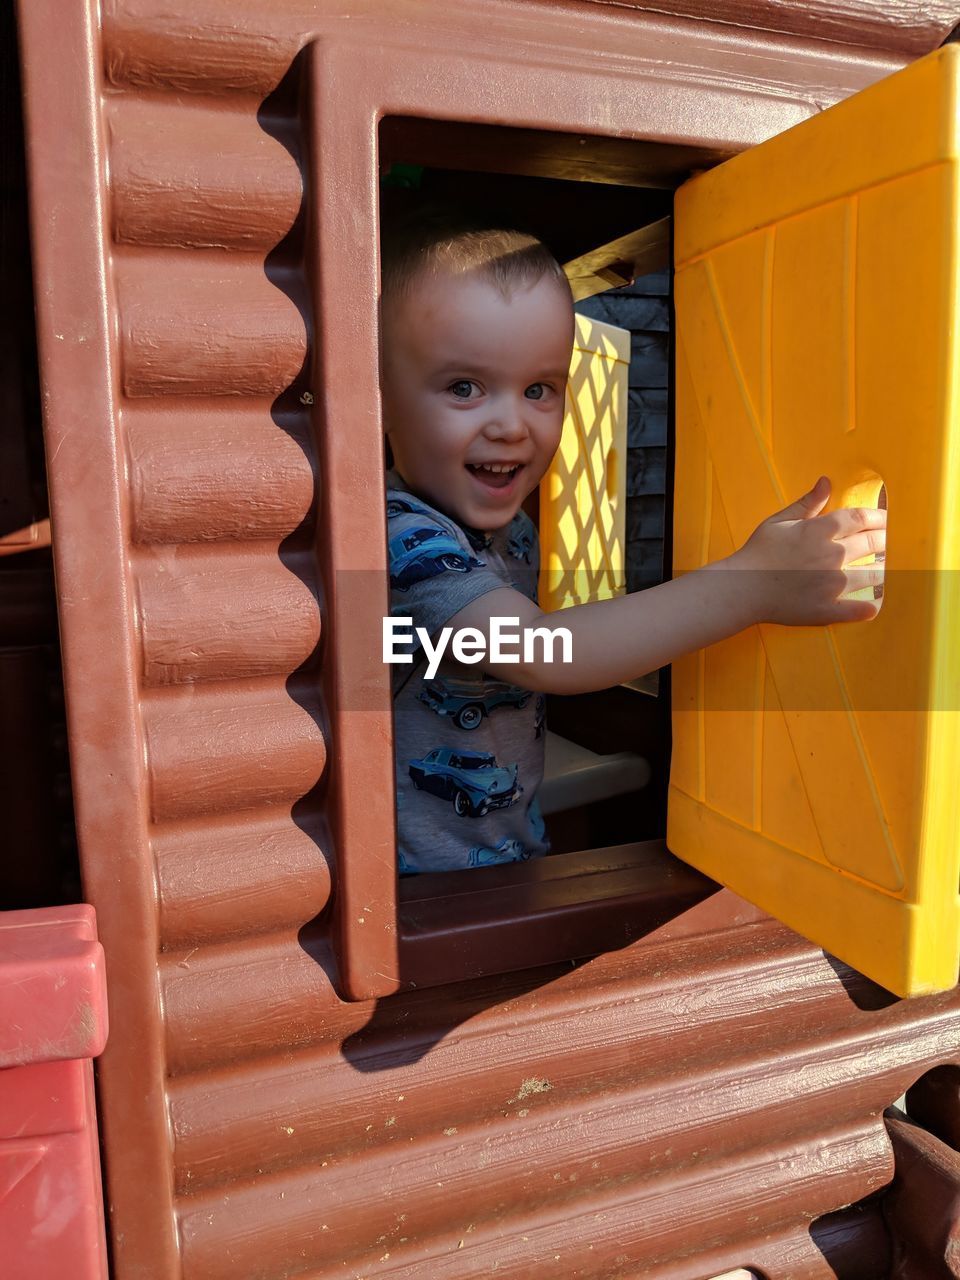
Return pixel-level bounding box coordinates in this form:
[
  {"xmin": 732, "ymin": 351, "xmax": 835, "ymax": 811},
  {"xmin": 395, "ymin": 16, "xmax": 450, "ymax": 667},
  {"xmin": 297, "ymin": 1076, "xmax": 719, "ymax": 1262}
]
[{"xmin": 0, "ymin": 906, "xmax": 108, "ymax": 1280}]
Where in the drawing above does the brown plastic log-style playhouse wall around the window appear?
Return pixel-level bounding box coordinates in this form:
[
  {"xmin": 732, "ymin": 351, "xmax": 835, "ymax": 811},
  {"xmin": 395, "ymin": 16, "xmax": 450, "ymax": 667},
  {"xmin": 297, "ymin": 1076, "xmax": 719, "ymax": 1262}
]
[{"xmin": 13, "ymin": 0, "xmax": 960, "ymax": 1280}]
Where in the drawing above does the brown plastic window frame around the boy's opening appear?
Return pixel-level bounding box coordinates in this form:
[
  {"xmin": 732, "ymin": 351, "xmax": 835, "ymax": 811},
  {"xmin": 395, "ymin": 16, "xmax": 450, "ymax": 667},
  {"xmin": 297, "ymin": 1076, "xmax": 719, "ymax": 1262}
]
[{"xmin": 306, "ymin": 29, "xmax": 870, "ymax": 1000}]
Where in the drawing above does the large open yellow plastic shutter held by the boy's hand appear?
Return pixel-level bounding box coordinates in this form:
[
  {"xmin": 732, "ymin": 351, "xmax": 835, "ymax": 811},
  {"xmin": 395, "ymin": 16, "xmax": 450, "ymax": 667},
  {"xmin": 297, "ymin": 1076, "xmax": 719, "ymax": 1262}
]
[{"xmin": 667, "ymin": 46, "xmax": 960, "ymax": 995}]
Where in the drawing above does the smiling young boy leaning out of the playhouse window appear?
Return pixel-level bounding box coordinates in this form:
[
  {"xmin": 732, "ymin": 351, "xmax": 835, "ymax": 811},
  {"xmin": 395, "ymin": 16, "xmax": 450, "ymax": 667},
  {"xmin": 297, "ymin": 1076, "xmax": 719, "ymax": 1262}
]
[{"xmin": 381, "ymin": 221, "xmax": 886, "ymax": 873}]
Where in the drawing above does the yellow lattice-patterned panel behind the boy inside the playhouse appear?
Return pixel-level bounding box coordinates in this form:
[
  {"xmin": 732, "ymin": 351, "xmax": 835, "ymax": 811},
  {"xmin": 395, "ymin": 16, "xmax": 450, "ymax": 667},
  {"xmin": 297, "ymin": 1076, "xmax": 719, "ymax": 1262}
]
[{"xmin": 539, "ymin": 315, "xmax": 630, "ymax": 609}]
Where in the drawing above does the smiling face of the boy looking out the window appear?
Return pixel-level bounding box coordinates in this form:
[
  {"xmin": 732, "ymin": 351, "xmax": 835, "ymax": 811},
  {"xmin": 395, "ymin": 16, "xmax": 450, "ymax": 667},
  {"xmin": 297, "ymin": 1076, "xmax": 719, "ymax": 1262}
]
[{"xmin": 383, "ymin": 270, "xmax": 573, "ymax": 532}]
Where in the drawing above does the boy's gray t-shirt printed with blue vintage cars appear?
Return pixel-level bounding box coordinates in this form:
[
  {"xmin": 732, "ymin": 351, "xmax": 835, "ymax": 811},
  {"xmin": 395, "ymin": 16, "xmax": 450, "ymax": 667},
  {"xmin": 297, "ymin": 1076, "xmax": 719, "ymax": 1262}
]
[{"xmin": 387, "ymin": 471, "xmax": 549, "ymax": 874}]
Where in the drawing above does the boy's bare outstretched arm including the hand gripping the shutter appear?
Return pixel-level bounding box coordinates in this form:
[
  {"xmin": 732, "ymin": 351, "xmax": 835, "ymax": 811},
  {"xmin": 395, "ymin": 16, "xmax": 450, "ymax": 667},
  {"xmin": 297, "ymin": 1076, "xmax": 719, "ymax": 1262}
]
[{"xmin": 448, "ymin": 477, "xmax": 886, "ymax": 694}]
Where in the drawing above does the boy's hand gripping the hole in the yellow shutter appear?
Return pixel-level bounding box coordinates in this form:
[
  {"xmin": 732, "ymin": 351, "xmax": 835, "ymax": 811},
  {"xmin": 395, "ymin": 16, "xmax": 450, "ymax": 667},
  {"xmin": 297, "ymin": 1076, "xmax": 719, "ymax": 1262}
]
[{"xmin": 732, "ymin": 476, "xmax": 887, "ymax": 626}]
